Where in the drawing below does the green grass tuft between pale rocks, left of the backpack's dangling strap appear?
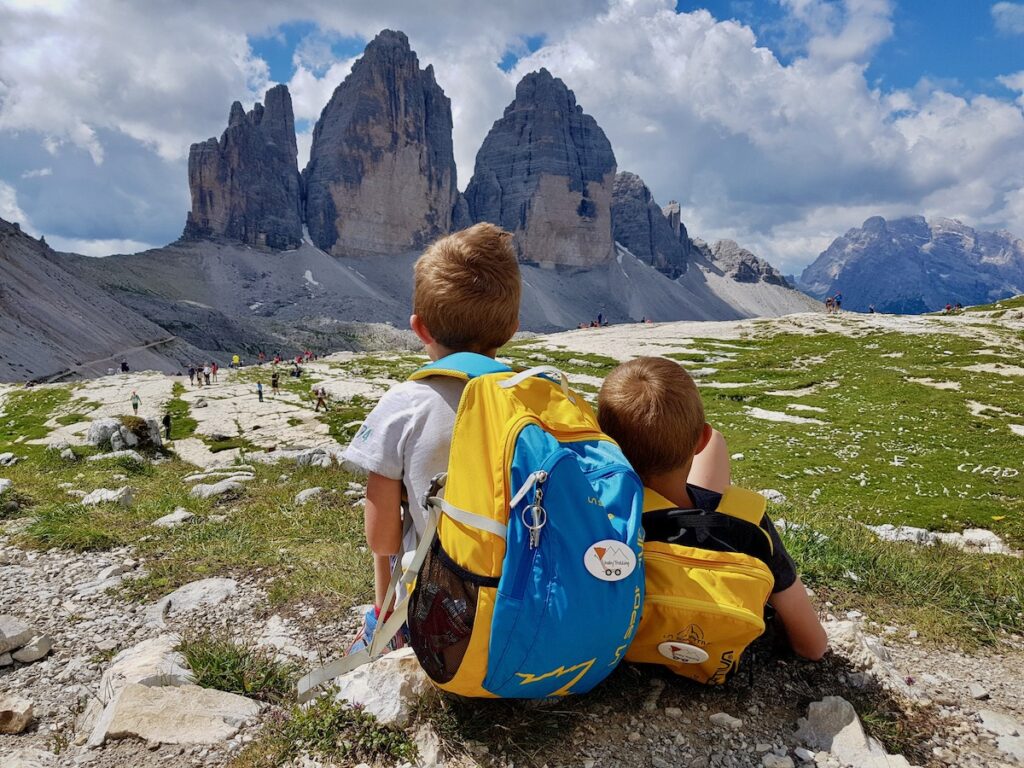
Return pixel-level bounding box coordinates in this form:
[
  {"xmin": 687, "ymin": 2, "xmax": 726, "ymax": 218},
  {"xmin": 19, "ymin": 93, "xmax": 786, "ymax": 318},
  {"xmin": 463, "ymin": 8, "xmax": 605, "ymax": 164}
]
[{"xmin": 178, "ymin": 633, "xmax": 299, "ymax": 703}]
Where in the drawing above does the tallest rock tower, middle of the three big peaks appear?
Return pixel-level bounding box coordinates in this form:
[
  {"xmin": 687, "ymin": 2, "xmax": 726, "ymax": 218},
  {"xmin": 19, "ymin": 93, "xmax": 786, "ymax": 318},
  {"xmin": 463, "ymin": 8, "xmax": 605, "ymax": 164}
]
[{"xmin": 303, "ymin": 30, "xmax": 459, "ymax": 256}]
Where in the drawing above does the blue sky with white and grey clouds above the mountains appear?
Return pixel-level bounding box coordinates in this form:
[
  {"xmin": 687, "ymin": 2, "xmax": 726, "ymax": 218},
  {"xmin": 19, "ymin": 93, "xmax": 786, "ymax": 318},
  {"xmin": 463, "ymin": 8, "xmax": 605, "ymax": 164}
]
[{"xmin": 0, "ymin": 0, "xmax": 1024, "ymax": 272}]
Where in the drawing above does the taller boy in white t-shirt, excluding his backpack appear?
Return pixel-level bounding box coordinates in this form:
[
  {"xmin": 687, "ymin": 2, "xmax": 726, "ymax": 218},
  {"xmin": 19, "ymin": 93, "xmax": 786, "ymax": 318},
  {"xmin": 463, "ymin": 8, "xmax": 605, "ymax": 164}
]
[{"xmin": 344, "ymin": 223, "xmax": 521, "ymax": 652}]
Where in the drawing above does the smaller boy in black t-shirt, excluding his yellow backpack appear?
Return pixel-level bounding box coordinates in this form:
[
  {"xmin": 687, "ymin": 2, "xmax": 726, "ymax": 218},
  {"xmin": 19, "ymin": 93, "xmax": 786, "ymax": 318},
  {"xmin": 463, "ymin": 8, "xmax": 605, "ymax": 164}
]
[{"xmin": 597, "ymin": 357, "xmax": 827, "ymax": 660}]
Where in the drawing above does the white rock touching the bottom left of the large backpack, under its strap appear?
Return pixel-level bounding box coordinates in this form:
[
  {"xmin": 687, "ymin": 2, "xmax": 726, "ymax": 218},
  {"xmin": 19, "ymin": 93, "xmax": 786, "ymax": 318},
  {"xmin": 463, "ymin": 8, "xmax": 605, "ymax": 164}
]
[{"xmin": 337, "ymin": 647, "xmax": 433, "ymax": 726}]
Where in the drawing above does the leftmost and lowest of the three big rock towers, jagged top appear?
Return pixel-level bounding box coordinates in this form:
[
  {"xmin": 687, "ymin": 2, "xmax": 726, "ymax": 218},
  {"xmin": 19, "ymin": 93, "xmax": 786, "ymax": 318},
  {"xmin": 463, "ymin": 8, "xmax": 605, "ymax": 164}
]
[{"xmin": 182, "ymin": 85, "xmax": 302, "ymax": 249}]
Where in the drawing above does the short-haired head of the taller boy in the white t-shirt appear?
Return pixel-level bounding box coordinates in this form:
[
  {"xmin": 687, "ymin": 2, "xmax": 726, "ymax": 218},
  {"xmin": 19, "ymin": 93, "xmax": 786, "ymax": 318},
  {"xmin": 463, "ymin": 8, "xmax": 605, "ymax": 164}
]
[{"xmin": 413, "ymin": 222, "xmax": 522, "ymax": 353}]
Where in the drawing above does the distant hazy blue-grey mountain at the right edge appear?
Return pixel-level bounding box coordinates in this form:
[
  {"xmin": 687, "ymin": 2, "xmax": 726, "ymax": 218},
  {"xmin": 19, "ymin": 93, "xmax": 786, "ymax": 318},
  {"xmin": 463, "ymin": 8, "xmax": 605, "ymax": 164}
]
[{"xmin": 798, "ymin": 216, "xmax": 1024, "ymax": 313}]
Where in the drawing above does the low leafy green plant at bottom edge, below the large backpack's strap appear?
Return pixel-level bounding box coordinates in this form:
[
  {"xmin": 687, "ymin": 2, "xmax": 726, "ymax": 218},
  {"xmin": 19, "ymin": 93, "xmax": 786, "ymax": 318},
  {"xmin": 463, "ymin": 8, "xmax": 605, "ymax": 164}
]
[{"xmin": 231, "ymin": 694, "xmax": 416, "ymax": 768}]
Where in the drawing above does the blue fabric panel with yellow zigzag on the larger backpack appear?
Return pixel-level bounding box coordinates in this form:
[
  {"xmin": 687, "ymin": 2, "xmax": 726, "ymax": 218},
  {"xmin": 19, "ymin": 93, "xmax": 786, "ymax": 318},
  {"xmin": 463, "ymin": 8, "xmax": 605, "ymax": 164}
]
[{"xmin": 483, "ymin": 425, "xmax": 644, "ymax": 698}]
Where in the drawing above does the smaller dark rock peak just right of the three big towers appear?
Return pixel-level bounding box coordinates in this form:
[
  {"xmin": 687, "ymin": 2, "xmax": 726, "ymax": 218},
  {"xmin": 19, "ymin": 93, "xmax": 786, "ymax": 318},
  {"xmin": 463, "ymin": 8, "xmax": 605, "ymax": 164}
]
[{"xmin": 611, "ymin": 171, "xmax": 690, "ymax": 280}]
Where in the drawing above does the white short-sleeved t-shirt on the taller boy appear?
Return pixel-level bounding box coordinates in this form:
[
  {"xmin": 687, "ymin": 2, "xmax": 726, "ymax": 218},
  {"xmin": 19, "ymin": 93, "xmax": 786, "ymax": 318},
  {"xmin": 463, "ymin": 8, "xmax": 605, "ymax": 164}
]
[{"xmin": 344, "ymin": 376, "xmax": 466, "ymax": 552}]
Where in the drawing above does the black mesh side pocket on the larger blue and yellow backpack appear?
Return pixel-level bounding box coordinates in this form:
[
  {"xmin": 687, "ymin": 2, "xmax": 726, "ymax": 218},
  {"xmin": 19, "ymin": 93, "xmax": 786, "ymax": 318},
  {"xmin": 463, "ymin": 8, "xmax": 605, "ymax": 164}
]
[{"xmin": 408, "ymin": 538, "xmax": 498, "ymax": 683}]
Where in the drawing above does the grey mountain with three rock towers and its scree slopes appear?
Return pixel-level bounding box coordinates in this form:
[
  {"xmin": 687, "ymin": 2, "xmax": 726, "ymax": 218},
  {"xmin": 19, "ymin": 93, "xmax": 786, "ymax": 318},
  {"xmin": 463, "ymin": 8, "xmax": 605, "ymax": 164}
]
[{"xmin": 0, "ymin": 30, "xmax": 820, "ymax": 380}]
